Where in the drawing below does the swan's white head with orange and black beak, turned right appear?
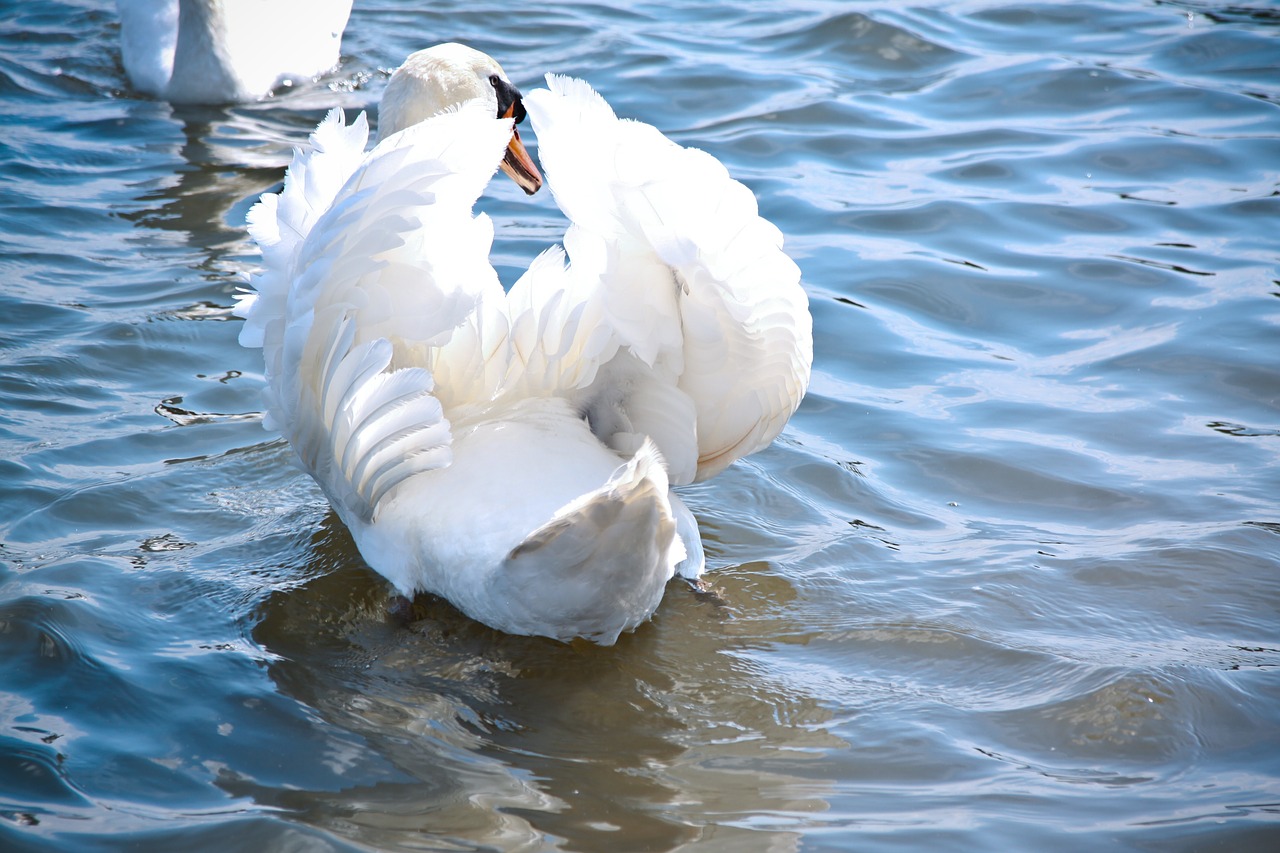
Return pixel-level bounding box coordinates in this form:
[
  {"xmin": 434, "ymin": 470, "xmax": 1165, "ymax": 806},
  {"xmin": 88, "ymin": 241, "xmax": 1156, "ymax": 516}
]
[{"xmin": 378, "ymin": 42, "xmax": 543, "ymax": 195}]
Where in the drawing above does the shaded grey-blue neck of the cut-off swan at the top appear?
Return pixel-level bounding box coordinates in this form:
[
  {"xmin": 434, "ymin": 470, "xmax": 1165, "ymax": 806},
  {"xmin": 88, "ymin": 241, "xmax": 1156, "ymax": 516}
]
[{"xmin": 169, "ymin": 0, "xmax": 242, "ymax": 102}]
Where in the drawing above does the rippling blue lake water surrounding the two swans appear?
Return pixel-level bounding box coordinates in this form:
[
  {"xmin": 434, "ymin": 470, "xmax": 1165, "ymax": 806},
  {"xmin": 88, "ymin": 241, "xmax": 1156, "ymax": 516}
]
[{"xmin": 0, "ymin": 0, "xmax": 1280, "ymax": 852}]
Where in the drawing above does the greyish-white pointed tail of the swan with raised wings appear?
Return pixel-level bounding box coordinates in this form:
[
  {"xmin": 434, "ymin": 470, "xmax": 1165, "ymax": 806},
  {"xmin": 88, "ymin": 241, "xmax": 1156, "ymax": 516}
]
[{"xmin": 493, "ymin": 442, "xmax": 687, "ymax": 646}]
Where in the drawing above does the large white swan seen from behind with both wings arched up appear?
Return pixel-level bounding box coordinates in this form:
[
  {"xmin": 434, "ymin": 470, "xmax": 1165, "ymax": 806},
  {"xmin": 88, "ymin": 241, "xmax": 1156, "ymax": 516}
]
[{"xmin": 241, "ymin": 45, "xmax": 812, "ymax": 644}]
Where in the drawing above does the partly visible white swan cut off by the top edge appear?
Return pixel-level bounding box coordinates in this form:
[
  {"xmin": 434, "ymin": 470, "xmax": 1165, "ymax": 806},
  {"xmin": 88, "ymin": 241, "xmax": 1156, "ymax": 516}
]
[{"xmin": 116, "ymin": 0, "xmax": 352, "ymax": 104}]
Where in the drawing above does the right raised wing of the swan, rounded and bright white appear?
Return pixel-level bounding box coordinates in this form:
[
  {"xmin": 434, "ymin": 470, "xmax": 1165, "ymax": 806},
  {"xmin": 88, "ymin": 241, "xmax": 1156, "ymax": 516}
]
[{"xmin": 525, "ymin": 74, "xmax": 813, "ymax": 484}]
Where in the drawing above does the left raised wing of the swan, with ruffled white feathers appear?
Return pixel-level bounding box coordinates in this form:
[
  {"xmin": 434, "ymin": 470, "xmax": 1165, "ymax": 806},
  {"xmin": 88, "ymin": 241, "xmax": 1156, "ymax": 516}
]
[{"xmin": 241, "ymin": 109, "xmax": 511, "ymax": 524}]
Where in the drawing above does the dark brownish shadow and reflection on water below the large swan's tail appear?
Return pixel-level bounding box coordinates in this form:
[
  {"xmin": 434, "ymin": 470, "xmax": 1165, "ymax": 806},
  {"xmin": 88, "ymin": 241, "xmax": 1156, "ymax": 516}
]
[{"xmin": 250, "ymin": 514, "xmax": 842, "ymax": 850}]
